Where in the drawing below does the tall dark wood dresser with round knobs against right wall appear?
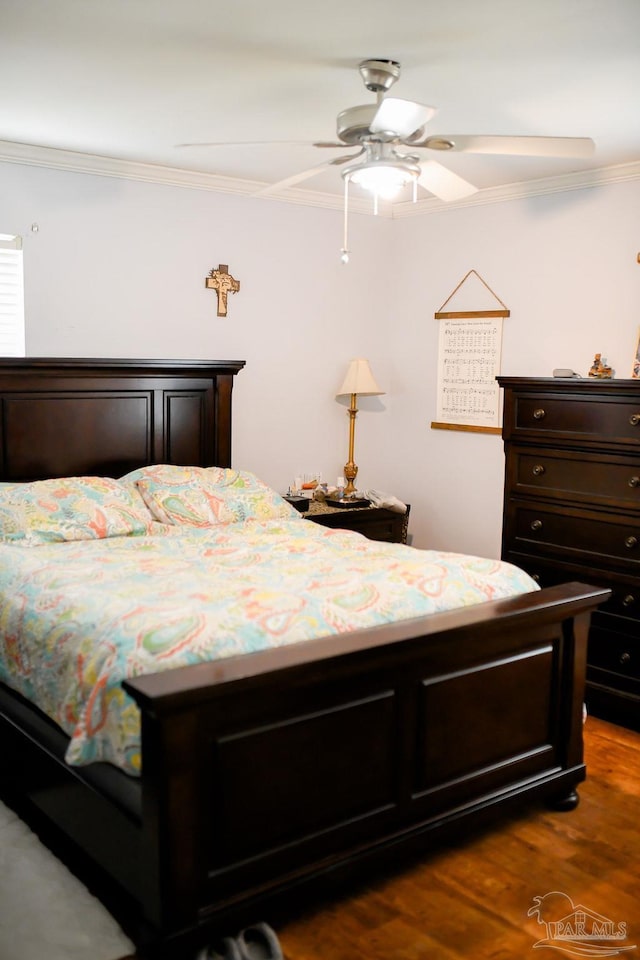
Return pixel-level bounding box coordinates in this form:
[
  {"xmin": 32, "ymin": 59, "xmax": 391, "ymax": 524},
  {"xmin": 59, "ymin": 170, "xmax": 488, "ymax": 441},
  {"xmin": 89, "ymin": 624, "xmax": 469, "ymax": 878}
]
[{"xmin": 498, "ymin": 377, "xmax": 640, "ymax": 729}]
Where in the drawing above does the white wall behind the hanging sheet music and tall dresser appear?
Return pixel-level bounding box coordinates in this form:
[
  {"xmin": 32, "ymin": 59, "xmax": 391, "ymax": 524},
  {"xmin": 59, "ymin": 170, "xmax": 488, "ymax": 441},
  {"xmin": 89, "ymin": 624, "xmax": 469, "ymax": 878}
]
[{"xmin": 392, "ymin": 182, "xmax": 640, "ymax": 556}]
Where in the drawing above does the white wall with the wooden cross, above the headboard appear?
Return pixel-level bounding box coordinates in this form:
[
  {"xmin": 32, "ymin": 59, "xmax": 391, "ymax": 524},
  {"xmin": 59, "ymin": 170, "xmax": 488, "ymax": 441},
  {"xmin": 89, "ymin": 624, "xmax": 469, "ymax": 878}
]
[{"xmin": 0, "ymin": 164, "xmax": 393, "ymax": 490}]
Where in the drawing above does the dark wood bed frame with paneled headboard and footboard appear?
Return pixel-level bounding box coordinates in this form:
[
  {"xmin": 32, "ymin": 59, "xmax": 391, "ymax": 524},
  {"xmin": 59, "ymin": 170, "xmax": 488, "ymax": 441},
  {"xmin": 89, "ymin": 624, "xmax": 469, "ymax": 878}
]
[{"xmin": 0, "ymin": 359, "xmax": 609, "ymax": 958}]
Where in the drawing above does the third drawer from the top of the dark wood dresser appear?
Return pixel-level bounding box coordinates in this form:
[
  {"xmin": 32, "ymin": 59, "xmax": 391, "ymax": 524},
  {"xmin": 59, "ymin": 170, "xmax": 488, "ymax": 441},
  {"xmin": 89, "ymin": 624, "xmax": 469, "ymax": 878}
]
[{"xmin": 504, "ymin": 500, "xmax": 640, "ymax": 575}]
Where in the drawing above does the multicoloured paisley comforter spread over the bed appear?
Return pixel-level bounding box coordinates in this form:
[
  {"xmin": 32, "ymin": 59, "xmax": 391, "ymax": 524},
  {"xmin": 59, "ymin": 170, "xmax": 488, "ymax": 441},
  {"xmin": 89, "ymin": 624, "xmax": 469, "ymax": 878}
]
[{"xmin": 0, "ymin": 518, "xmax": 537, "ymax": 774}]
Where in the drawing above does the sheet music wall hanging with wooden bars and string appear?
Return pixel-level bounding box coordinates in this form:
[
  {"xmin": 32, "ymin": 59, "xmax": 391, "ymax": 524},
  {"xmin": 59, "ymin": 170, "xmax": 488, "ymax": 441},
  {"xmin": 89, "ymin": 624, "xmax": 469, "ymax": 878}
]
[{"xmin": 431, "ymin": 270, "xmax": 509, "ymax": 433}]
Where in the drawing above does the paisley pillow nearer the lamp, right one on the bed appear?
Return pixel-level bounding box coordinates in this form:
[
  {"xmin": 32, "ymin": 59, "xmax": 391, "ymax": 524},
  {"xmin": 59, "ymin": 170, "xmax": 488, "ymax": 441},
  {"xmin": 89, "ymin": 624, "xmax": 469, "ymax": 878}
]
[{"xmin": 126, "ymin": 464, "xmax": 301, "ymax": 527}]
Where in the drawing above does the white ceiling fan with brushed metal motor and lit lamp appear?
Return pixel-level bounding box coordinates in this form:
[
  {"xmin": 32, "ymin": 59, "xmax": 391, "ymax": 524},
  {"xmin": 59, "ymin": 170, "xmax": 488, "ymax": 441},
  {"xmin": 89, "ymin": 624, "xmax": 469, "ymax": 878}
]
[{"xmin": 249, "ymin": 60, "xmax": 595, "ymax": 201}]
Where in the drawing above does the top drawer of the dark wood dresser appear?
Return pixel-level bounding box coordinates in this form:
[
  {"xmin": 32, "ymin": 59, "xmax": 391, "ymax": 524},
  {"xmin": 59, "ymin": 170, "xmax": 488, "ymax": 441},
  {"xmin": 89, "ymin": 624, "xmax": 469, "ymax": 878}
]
[{"xmin": 504, "ymin": 391, "xmax": 640, "ymax": 447}]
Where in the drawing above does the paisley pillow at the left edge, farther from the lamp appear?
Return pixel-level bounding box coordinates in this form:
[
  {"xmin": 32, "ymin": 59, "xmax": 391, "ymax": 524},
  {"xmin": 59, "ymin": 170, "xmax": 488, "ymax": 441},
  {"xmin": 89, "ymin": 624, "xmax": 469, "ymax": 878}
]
[{"xmin": 0, "ymin": 477, "xmax": 153, "ymax": 547}]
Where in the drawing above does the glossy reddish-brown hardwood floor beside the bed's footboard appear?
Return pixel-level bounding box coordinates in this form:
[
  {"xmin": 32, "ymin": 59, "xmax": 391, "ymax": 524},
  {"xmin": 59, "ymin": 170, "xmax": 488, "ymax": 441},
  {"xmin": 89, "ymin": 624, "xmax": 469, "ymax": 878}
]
[{"xmin": 277, "ymin": 717, "xmax": 640, "ymax": 960}]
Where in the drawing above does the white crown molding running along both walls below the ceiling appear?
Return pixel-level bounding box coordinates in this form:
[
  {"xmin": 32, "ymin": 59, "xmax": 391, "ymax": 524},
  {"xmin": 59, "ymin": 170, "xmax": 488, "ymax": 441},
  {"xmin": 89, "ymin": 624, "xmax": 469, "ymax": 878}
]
[{"xmin": 0, "ymin": 140, "xmax": 640, "ymax": 219}]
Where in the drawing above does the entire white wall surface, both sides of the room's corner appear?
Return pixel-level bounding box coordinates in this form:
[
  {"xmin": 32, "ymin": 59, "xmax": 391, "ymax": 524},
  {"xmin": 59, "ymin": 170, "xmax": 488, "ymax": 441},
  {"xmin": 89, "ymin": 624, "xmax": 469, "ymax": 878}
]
[{"xmin": 0, "ymin": 164, "xmax": 640, "ymax": 556}]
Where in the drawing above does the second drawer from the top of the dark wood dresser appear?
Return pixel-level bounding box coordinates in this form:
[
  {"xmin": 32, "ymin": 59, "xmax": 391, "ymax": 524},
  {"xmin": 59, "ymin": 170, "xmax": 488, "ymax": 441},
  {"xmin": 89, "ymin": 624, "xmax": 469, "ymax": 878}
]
[{"xmin": 507, "ymin": 445, "xmax": 640, "ymax": 516}]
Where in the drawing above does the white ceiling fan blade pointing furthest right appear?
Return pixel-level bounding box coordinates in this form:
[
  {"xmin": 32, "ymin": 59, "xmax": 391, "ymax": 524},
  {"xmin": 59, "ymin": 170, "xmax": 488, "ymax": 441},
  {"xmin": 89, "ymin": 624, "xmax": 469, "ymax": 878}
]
[{"xmin": 412, "ymin": 134, "xmax": 596, "ymax": 158}]
